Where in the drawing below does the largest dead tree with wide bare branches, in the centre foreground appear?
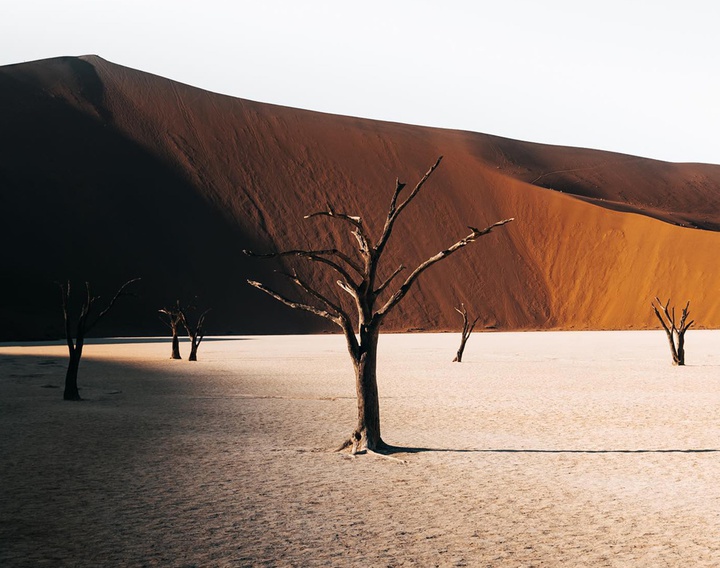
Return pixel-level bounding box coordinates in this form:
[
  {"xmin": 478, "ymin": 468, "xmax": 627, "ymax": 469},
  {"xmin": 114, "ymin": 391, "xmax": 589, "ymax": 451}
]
[{"xmin": 245, "ymin": 156, "xmax": 512, "ymax": 453}]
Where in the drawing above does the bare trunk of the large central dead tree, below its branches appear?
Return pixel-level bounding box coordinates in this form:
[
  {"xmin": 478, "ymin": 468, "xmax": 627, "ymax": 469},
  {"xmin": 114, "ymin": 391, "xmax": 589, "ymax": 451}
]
[{"xmin": 351, "ymin": 329, "xmax": 385, "ymax": 452}]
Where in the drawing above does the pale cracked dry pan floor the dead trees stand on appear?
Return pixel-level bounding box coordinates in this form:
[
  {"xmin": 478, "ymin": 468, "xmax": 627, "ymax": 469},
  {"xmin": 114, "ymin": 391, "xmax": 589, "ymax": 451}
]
[{"xmin": 0, "ymin": 330, "xmax": 720, "ymax": 567}]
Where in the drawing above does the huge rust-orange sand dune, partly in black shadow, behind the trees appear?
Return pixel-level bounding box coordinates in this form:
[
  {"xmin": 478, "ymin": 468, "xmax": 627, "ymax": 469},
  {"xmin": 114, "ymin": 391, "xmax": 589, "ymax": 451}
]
[{"xmin": 0, "ymin": 56, "xmax": 720, "ymax": 340}]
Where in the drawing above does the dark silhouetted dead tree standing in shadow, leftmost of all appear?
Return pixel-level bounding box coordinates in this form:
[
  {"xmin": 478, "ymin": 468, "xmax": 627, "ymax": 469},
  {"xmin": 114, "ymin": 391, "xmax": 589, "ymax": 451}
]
[{"xmin": 58, "ymin": 278, "xmax": 140, "ymax": 400}]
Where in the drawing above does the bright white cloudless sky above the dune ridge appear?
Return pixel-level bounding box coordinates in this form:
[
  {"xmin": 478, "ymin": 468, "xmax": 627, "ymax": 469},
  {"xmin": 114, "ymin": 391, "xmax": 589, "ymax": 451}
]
[{"xmin": 0, "ymin": 0, "xmax": 720, "ymax": 164}]
